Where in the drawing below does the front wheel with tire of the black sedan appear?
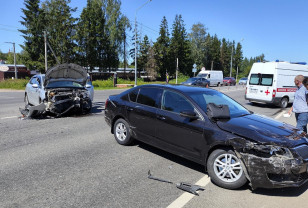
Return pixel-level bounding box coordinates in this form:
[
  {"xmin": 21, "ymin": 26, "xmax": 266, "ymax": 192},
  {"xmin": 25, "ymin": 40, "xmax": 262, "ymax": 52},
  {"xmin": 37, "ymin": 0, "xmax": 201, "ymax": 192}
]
[{"xmin": 207, "ymin": 149, "xmax": 247, "ymax": 189}]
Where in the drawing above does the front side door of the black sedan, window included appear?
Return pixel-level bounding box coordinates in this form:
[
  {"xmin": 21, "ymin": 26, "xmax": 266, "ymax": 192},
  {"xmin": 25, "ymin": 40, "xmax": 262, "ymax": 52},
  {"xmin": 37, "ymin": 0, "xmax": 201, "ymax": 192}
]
[{"xmin": 157, "ymin": 90, "xmax": 206, "ymax": 161}]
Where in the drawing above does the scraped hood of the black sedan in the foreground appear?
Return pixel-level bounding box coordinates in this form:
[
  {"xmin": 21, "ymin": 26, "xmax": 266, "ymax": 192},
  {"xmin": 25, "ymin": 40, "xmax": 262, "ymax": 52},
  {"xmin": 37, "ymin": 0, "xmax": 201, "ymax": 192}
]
[{"xmin": 217, "ymin": 114, "xmax": 308, "ymax": 147}]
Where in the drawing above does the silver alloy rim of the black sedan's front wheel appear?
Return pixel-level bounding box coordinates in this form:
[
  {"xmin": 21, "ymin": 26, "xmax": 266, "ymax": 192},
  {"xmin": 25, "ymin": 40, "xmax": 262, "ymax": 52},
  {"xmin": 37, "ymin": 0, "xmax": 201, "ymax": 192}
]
[{"xmin": 214, "ymin": 154, "xmax": 243, "ymax": 183}]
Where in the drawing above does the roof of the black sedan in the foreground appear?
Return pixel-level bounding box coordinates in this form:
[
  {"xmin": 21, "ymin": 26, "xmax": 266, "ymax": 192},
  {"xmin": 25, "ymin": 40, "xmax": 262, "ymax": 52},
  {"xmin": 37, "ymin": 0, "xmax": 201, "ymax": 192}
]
[{"xmin": 138, "ymin": 84, "xmax": 218, "ymax": 93}]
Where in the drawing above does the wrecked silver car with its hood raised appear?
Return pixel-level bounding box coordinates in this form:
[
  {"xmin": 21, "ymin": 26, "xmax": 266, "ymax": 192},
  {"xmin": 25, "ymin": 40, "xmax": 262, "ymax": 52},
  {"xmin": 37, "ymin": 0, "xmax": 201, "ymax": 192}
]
[{"xmin": 21, "ymin": 63, "xmax": 93, "ymax": 117}]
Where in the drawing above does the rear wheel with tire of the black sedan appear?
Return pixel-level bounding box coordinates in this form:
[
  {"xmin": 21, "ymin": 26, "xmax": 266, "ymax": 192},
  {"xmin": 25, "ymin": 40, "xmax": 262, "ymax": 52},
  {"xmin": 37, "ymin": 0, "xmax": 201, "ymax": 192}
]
[{"xmin": 113, "ymin": 118, "xmax": 133, "ymax": 145}]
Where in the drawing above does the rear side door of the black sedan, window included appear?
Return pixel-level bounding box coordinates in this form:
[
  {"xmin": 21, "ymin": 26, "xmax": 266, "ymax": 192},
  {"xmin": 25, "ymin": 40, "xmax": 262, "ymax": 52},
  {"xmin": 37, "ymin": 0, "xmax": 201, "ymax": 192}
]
[{"xmin": 126, "ymin": 87, "xmax": 163, "ymax": 143}]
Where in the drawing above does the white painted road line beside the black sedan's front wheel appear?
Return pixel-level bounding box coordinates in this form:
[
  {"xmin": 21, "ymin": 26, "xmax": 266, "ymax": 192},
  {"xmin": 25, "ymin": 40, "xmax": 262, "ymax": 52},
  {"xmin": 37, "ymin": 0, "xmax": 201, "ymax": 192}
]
[{"xmin": 167, "ymin": 175, "xmax": 211, "ymax": 208}]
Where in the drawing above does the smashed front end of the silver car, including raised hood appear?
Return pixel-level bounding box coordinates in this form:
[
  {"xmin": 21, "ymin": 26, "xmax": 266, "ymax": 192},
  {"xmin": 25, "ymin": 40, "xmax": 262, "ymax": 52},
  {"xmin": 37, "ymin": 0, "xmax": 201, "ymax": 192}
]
[{"xmin": 20, "ymin": 64, "xmax": 92, "ymax": 118}]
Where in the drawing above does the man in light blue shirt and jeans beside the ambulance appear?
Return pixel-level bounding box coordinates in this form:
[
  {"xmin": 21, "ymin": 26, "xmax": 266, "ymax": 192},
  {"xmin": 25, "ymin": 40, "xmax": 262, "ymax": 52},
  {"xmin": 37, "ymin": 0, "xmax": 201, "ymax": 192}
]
[{"xmin": 288, "ymin": 75, "xmax": 308, "ymax": 133}]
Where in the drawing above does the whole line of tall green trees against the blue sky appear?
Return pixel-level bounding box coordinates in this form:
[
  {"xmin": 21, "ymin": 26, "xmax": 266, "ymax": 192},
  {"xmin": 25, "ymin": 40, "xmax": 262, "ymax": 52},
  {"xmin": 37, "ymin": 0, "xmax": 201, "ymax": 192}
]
[{"xmin": 9, "ymin": 0, "xmax": 264, "ymax": 79}]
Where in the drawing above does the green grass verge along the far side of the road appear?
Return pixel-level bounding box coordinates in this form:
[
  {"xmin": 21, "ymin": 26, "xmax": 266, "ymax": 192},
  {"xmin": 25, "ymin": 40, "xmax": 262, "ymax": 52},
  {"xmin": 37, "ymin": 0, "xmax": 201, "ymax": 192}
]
[{"xmin": 0, "ymin": 74, "xmax": 189, "ymax": 90}]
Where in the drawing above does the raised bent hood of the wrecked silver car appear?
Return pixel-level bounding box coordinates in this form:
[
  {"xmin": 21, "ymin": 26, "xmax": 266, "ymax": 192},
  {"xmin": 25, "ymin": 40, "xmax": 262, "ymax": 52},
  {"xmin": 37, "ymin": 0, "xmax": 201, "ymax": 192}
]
[{"xmin": 44, "ymin": 63, "xmax": 87, "ymax": 86}]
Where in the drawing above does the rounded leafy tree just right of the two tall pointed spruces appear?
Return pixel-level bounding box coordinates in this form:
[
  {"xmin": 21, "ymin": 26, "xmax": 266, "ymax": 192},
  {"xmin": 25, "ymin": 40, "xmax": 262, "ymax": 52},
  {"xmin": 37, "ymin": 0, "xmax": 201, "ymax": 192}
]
[{"xmin": 189, "ymin": 23, "xmax": 206, "ymax": 68}]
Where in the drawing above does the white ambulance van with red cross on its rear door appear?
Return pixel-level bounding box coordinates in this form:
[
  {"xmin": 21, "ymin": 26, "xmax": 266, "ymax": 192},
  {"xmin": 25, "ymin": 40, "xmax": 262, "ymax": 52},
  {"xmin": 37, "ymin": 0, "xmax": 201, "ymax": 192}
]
[{"xmin": 245, "ymin": 61, "xmax": 308, "ymax": 108}]
